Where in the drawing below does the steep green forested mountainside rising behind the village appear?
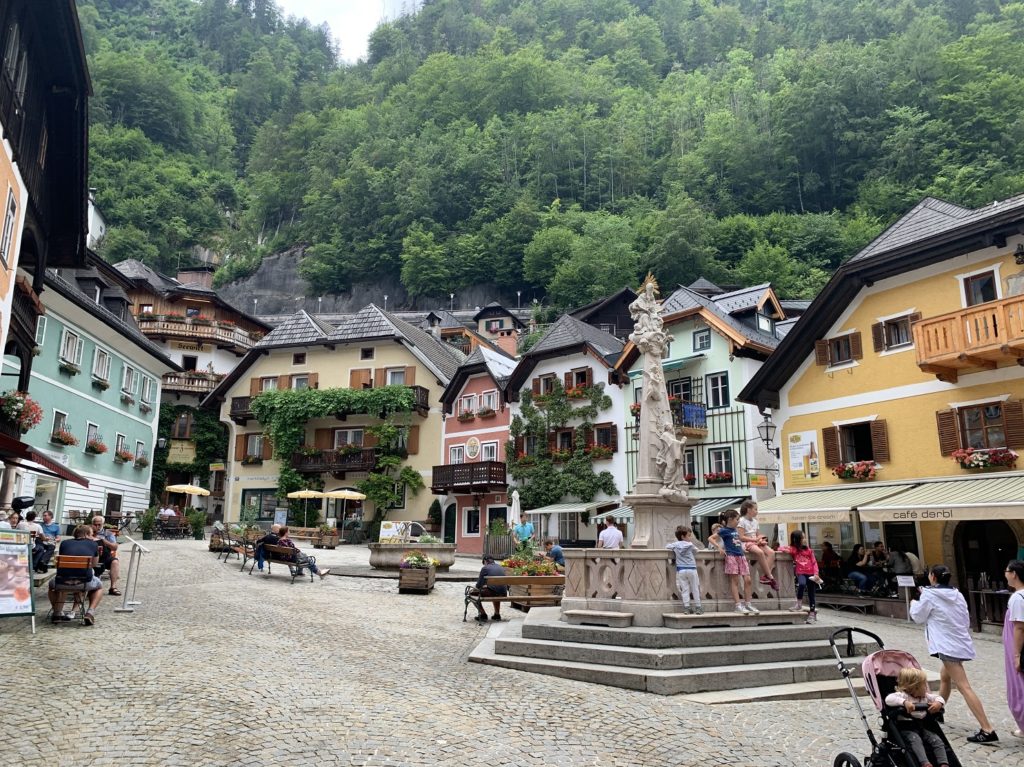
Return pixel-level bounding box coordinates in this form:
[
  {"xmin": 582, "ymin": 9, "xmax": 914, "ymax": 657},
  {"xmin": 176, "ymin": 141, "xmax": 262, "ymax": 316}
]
[{"xmin": 79, "ymin": 0, "xmax": 1024, "ymax": 305}]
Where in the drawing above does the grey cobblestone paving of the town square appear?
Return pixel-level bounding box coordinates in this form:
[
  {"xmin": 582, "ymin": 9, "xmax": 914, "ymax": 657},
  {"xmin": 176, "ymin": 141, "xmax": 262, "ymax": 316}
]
[{"xmin": 0, "ymin": 541, "xmax": 1024, "ymax": 767}]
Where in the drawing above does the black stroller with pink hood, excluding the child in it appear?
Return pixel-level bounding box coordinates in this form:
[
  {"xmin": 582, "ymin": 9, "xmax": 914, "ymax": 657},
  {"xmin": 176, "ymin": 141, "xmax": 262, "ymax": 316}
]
[{"xmin": 828, "ymin": 628, "xmax": 962, "ymax": 767}]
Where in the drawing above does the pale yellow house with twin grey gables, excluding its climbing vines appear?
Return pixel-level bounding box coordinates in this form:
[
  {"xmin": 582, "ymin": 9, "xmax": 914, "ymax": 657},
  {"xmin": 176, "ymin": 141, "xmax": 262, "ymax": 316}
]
[{"xmin": 204, "ymin": 305, "xmax": 464, "ymax": 520}]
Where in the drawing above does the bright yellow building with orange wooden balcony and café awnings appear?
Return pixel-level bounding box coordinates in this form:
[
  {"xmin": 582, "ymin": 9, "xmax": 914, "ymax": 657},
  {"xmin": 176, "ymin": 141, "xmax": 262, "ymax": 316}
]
[{"xmin": 739, "ymin": 197, "xmax": 1024, "ymax": 586}]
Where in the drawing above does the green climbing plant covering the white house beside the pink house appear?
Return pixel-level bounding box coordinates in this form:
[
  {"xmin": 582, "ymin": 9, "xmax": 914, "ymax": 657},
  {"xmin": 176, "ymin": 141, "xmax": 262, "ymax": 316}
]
[{"xmin": 505, "ymin": 381, "xmax": 618, "ymax": 509}]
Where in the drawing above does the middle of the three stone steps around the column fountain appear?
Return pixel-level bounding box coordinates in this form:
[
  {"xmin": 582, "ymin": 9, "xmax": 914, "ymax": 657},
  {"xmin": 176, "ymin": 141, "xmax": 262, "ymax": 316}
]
[{"xmin": 495, "ymin": 626, "xmax": 873, "ymax": 669}]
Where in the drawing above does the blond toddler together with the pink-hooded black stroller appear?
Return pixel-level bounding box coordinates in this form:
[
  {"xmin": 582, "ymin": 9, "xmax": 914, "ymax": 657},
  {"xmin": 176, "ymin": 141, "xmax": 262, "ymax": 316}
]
[{"xmin": 828, "ymin": 628, "xmax": 962, "ymax": 767}]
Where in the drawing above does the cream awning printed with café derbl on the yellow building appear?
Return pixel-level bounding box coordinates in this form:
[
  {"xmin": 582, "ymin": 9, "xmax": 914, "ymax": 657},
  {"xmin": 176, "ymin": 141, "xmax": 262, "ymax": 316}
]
[{"xmin": 859, "ymin": 474, "xmax": 1024, "ymax": 522}]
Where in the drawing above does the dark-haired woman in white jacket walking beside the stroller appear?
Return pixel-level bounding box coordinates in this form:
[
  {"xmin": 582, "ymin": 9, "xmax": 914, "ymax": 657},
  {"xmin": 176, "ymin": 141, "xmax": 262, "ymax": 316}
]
[{"xmin": 910, "ymin": 564, "xmax": 999, "ymax": 743}]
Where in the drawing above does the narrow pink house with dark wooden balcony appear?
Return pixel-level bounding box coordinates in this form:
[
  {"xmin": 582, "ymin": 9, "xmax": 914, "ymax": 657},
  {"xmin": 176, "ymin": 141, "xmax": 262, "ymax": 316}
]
[{"xmin": 431, "ymin": 344, "xmax": 515, "ymax": 554}]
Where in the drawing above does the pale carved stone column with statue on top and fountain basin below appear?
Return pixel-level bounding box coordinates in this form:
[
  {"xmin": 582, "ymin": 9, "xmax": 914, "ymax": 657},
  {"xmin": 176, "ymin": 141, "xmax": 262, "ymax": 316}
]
[{"xmin": 561, "ymin": 274, "xmax": 793, "ymax": 627}]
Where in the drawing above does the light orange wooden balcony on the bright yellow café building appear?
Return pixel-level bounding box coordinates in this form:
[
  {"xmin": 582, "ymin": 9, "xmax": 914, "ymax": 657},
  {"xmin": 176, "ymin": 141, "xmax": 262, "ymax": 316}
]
[{"xmin": 912, "ymin": 296, "xmax": 1024, "ymax": 383}]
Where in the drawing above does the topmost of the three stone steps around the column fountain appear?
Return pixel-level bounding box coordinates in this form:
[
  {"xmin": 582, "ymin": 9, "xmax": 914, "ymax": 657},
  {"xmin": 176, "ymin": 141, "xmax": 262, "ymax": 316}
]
[{"xmin": 522, "ymin": 607, "xmax": 836, "ymax": 648}]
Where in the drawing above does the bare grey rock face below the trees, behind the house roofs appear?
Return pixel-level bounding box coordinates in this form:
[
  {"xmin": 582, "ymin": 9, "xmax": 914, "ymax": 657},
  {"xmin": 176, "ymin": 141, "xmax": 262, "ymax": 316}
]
[{"xmin": 218, "ymin": 248, "xmax": 542, "ymax": 316}]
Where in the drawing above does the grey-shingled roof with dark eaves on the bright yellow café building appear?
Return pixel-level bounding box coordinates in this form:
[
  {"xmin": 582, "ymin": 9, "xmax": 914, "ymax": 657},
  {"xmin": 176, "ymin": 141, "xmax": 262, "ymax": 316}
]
[{"xmin": 736, "ymin": 195, "xmax": 1024, "ymax": 410}]
